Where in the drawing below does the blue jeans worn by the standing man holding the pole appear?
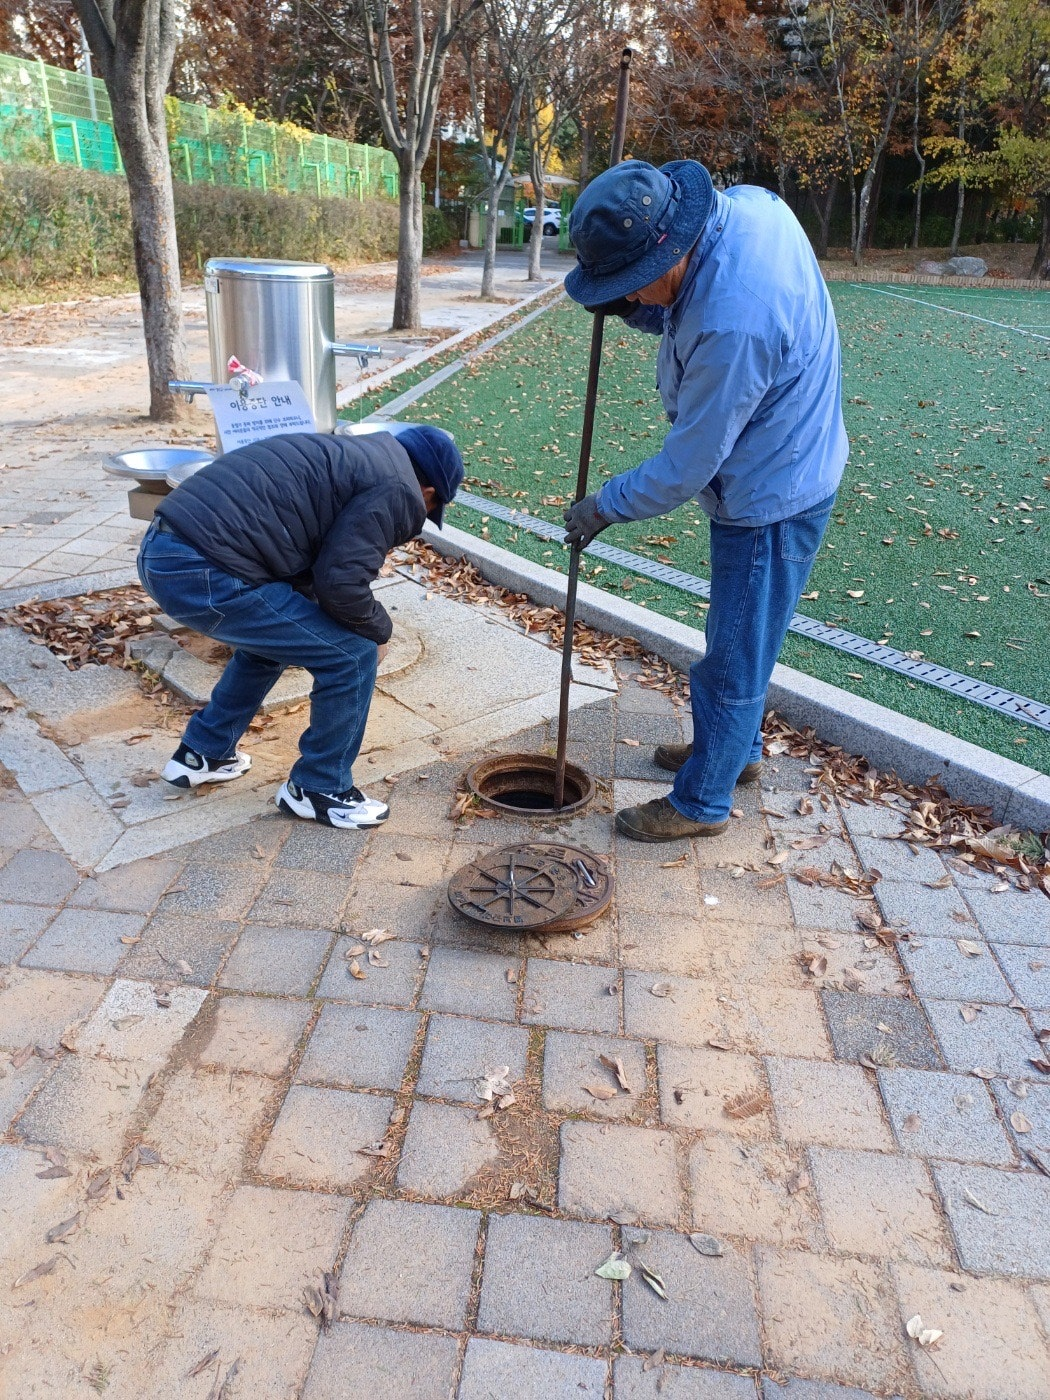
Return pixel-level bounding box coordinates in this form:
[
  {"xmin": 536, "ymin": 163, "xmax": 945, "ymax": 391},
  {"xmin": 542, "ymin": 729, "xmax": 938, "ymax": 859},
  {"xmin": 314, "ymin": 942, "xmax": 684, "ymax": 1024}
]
[{"xmin": 671, "ymin": 496, "xmax": 834, "ymax": 822}]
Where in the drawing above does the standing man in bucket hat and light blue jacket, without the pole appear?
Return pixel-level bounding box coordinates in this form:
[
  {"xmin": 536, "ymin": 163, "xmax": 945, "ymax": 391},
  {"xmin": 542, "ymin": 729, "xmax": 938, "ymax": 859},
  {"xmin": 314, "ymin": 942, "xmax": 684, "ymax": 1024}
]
[{"xmin": 566, "ymin": 161, "xmax": 848, "ymax": 841}]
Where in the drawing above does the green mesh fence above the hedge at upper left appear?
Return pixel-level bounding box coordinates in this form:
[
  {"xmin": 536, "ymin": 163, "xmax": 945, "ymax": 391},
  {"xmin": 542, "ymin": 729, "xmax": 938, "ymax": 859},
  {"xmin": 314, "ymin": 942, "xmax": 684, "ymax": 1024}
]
[{"xmin": 0, "ymin": 53, "xmax": 398, "ymax": 199}]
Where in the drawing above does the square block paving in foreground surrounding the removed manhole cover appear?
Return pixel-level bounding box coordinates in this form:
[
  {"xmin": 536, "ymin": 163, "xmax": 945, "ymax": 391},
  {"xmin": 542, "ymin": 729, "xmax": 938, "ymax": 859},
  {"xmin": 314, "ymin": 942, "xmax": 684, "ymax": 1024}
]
[{"xmin": 0, "ymin": 675, "xmax": 1050, "ymax": 1400}]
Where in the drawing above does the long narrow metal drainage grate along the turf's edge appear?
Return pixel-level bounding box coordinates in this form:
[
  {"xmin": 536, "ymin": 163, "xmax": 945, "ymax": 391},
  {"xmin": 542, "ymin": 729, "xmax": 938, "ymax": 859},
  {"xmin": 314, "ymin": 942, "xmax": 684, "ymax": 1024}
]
[{"xmin": 456, "ymin": 491, "xmax": 1050, "ymax": 729}]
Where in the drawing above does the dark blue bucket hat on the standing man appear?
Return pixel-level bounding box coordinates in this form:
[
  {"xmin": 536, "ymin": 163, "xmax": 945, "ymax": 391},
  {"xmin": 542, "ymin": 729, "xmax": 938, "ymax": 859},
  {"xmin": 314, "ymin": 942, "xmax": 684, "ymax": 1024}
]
[{"xmin": 566, "ymin": 161, "xmax": 714, "ymax": 307}]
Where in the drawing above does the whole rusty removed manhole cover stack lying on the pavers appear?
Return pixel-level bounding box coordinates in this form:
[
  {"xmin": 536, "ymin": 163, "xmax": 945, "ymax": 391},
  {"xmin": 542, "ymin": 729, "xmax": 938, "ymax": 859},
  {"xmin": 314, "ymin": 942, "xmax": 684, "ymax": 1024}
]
[{"xmin": 448, "ymin": 841, "xmax": 613, "ymax": 934}]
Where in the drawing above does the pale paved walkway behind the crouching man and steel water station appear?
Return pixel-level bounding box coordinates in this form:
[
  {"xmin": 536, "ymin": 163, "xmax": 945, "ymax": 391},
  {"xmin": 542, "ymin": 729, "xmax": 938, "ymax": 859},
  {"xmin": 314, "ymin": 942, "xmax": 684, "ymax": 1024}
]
[{"xmin": 0, "ymin": 252, "xmax": 568, "ymax": 591}]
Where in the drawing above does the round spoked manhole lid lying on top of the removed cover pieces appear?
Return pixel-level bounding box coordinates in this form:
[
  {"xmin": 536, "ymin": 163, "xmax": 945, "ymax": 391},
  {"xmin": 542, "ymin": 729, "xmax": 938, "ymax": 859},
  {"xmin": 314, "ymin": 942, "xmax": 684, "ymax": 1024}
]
[{"xmin": 448, "ymin": 846, "xmax": 577, "ymax": 928}]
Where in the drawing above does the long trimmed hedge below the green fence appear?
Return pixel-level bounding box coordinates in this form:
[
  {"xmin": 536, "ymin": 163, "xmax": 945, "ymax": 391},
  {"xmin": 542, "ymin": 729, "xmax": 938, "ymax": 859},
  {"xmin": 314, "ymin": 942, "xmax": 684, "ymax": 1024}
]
[{"xmin": 0, "ymin": 165, "xmax": 403, "ymax": 287}]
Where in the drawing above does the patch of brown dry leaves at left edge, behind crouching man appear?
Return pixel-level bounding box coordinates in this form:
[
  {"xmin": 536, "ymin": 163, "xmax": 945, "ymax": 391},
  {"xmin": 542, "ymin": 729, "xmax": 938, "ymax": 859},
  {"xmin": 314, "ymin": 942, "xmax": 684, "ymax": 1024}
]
[{"xmin": 3, "ymin": 588, "xmax": 158, "ymax": 671}]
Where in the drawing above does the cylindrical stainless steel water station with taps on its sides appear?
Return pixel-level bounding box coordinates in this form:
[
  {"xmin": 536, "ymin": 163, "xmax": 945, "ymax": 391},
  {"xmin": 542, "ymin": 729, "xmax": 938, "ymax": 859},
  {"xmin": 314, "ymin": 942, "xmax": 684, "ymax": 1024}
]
[{"xmin": 172, "ymin": 258, "xmax": 384, "ymax": 433}]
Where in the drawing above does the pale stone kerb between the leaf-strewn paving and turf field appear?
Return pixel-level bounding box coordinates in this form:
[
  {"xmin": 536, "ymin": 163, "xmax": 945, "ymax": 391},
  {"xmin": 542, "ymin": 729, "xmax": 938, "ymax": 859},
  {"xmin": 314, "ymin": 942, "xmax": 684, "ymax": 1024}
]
[{"xmin": 423, "ymin": 524, "xmax": 1050, "ymax": 832}]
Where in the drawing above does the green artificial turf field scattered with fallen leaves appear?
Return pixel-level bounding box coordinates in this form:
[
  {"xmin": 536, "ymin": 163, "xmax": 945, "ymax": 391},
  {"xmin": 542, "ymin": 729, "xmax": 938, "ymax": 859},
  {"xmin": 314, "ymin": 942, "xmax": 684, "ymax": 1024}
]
[{"xmin": 375, "ymin": 283, "xmax": 1050, "ymax": 773}]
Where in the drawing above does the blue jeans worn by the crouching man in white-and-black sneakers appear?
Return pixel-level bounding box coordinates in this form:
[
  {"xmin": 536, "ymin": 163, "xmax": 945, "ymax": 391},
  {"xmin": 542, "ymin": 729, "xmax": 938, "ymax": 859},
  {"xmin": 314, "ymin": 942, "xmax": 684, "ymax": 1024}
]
[{"xmin": 139, "ymin": 525, "xmax": 379, "ymax": 792}]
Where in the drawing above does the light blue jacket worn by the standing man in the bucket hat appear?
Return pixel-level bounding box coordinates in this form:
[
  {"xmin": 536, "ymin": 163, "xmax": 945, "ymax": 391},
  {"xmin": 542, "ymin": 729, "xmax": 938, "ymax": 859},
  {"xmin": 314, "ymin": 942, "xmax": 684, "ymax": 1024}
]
[{"xmin": 598, "ymin": 185, "xmax": 850, "ymax": 525}]
